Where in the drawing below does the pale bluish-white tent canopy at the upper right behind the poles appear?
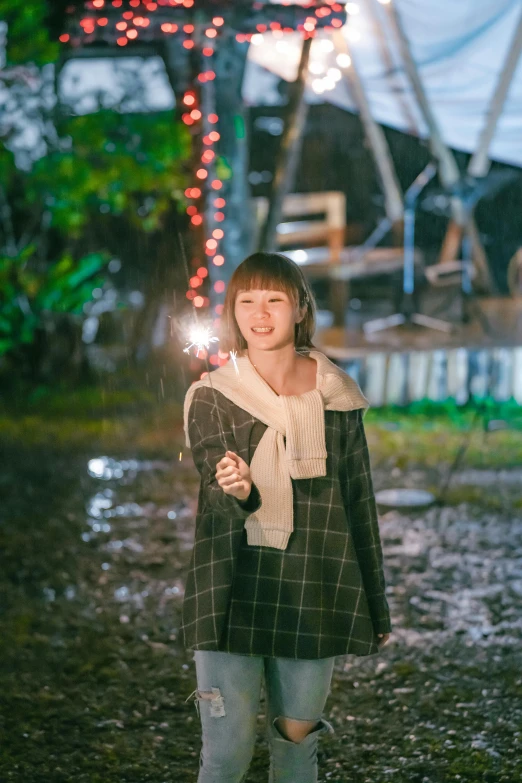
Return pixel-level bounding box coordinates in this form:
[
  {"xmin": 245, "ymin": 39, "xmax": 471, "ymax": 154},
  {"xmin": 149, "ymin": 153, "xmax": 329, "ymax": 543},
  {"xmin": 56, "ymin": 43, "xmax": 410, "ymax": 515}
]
[{"xmin": 244, "ymin": 0, "xmax": 522, "ymax": 166}]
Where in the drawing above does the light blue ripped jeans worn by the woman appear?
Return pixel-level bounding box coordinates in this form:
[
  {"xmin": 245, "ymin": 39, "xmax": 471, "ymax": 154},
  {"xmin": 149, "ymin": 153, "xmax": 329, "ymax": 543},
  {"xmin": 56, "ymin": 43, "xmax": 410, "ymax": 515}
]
[{"xmin": 186, "ymin": 650, "xmax": 335, "ymax": 783}]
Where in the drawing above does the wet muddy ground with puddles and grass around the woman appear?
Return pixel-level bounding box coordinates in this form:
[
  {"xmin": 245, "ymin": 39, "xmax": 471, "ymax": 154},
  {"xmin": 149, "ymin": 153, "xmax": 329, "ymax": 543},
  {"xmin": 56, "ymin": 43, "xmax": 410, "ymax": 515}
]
[{"xmin": 0, "ymin": 391, "xmax": 522, "ymax": 783}]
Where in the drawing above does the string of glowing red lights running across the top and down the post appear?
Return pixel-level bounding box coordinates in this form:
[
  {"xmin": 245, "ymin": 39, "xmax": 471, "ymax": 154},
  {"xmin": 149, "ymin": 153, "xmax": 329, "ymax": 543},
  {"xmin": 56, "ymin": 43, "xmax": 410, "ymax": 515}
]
[{"xmin": 59, "ymin": 0, "xmax": 346, "ymax": 380}]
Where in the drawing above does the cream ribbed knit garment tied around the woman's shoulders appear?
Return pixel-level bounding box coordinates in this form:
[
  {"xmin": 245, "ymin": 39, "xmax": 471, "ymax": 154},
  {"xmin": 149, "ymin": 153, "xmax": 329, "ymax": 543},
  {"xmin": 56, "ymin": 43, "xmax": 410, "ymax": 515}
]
[{"xmin": 184, "ymin": 350, "xmax": 369, "ymax": 549}]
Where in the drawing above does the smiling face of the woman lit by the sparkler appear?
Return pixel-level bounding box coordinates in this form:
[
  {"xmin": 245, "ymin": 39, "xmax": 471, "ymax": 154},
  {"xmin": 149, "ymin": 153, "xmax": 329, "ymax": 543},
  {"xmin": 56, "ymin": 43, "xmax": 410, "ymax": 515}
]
[{"xmin": 234, "ymin": 289, "xmax": 305, "ymax": 350}]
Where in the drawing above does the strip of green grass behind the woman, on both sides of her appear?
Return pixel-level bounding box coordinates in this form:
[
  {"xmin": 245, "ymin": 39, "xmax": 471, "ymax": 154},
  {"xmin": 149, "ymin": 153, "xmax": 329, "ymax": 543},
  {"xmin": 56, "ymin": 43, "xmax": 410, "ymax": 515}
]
[{"xmin": 0, "ymin": 382, "xmax": 522, "ymax": 469}]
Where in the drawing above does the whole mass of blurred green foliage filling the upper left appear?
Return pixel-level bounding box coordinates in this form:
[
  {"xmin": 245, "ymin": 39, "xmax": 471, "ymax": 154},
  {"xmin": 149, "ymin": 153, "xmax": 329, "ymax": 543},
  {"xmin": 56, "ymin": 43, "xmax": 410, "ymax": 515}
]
[{"xmin": 0, "ymin": 0, "xmax": 190, "ymax": 372}]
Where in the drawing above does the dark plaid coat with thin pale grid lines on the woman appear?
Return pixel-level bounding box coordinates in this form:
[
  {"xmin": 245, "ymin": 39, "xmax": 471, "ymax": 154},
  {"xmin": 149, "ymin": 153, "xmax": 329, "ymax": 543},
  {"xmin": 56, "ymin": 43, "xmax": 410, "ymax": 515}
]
[{"xmin": 181, "ymin": 387, "xmax": 391, "ymax": 659}]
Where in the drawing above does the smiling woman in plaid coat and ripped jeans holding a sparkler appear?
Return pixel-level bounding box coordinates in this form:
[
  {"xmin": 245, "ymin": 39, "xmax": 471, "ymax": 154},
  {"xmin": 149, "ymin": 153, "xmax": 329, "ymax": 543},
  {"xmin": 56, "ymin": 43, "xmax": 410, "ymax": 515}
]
[{"xmin": 182, "ymin": 253, "xmax": 391, "ymax": 783}]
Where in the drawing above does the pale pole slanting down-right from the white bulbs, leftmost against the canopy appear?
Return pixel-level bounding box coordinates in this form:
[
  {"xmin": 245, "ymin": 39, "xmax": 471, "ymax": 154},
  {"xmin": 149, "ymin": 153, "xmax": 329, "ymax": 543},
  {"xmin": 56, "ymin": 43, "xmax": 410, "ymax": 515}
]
[{"xmin": 332, "ymin": 30, "xmax": 404, "ymax": 226}]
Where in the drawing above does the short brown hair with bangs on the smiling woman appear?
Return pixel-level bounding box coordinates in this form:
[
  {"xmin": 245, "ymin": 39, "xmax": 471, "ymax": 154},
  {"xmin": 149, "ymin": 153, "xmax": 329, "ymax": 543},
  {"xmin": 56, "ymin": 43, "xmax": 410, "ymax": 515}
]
[{"xmin": 220, "ymin": 251, "xmax": 316, "ymax": 355}]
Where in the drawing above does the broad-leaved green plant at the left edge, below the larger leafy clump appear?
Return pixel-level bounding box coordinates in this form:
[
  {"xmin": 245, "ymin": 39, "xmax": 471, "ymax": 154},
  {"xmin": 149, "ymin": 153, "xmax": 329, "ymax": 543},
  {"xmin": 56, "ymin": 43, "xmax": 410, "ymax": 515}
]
[{"xmin": 0, "ymin": 245, "xmax": 109, "ymax": 356}]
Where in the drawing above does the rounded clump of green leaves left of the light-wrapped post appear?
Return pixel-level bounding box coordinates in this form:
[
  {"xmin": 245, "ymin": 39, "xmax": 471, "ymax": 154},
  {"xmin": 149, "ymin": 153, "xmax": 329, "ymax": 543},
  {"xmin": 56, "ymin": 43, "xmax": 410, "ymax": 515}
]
[{"xmin": 25, "ymin": 110, "xmax": 190, "ymax": 236}]
